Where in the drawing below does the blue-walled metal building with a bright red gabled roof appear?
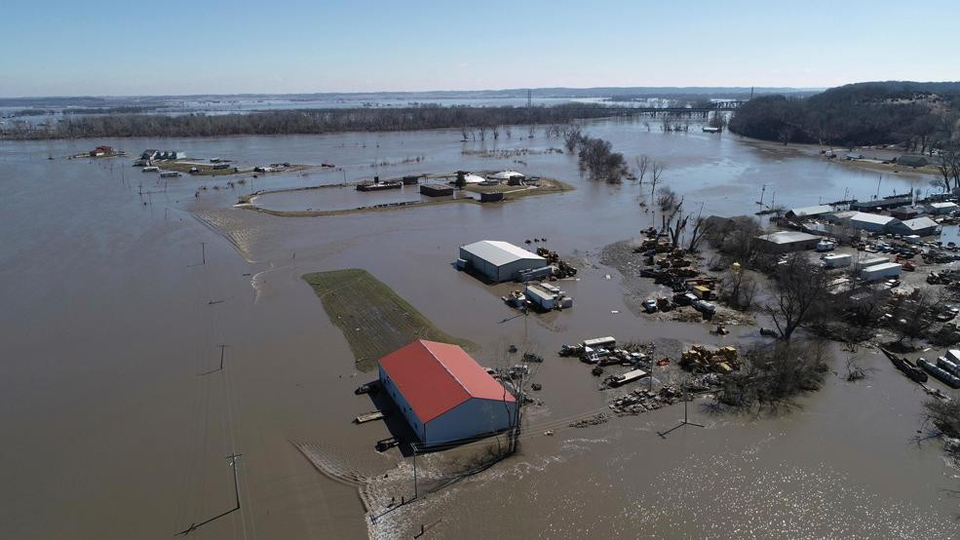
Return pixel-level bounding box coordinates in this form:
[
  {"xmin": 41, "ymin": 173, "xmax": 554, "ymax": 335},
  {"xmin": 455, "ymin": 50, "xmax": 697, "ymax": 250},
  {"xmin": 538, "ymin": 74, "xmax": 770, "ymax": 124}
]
[{"xmin": 380, "ymin": 339, "xmax": 517, "ymax": 446}]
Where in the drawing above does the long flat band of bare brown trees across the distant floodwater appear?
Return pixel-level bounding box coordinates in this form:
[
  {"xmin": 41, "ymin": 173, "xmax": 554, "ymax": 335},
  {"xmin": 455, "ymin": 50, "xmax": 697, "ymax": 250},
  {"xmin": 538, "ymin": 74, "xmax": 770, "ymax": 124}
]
[{"xmin": 2, "ymin": 104, "xmax": 609, "ymax": 139}]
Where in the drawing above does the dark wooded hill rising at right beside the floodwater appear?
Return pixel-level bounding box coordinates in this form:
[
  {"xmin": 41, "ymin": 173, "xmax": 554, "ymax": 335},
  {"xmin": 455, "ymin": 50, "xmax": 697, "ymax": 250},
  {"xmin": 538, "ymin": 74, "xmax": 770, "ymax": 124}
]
[{"xmin": 730, "ymin": 82, "xmax": 960, "ymax": 153}]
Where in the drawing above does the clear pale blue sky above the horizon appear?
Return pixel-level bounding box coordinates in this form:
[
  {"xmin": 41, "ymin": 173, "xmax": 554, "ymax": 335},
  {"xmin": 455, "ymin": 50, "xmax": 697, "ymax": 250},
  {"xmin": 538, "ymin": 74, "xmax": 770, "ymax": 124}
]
[{"xmin": 0, "ymin": 0, "xmax": 960, "ymax": 97}]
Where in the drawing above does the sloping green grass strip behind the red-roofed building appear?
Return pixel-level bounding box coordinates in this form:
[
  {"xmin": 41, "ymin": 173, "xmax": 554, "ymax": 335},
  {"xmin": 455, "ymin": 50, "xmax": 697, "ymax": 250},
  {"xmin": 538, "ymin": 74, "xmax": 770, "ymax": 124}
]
[{"xmin": 303, "ymin": 269, "xmax": 474, "ymax": 371}]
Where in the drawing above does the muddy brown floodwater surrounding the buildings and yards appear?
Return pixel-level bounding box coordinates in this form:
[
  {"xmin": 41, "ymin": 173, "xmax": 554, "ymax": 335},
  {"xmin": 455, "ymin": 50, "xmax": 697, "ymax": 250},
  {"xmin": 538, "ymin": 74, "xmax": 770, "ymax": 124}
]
[{"xmin": 0, "ymin": 121, "xmax": 958, "ymax": 538}]
